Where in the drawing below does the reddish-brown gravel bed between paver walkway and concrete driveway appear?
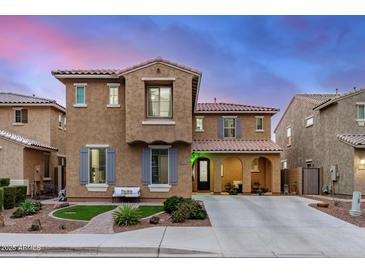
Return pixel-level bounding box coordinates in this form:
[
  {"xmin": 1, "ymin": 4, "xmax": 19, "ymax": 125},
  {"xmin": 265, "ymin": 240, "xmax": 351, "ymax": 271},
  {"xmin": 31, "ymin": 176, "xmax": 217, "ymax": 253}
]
[{"xmin": 114, "ymin": 213, "xmax": 211, "ymax": 233}]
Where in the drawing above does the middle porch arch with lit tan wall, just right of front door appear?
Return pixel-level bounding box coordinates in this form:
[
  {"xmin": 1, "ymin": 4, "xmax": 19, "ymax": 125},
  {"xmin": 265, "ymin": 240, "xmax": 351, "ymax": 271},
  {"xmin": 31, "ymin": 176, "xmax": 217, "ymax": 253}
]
[{"xmin": 221, "ymin": 156, "xmax": 243, "ymax": 191}]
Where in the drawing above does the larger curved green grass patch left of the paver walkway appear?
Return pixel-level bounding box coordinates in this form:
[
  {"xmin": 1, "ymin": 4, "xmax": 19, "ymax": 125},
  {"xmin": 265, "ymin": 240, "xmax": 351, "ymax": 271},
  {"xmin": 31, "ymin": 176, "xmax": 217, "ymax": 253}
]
[{"xmin": 53, "ymin": 205, "xmax": 117, "ymax": 221}]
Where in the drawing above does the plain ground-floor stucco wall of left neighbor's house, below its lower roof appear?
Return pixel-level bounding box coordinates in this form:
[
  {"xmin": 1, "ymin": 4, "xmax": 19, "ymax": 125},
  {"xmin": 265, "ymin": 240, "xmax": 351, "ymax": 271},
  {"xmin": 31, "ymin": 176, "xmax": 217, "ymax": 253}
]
[{"xmin": 0, "ymin": 138, "xmax": 24, "ymax": 180}]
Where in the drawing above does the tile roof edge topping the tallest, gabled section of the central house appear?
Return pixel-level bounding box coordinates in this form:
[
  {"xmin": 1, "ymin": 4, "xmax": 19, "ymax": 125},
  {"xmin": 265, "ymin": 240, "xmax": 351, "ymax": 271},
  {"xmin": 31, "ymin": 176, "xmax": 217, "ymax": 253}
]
[{"xmin": 52, "ymin": 56, "xmax": 201, "ymax": 76}]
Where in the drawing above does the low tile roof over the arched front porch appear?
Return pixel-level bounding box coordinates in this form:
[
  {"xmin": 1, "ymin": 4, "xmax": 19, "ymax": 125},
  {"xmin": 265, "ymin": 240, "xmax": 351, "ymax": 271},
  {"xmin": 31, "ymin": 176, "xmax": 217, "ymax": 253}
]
[{"xmin": 192, "ymin": 139, "xmax": 282, "ymax": 152}]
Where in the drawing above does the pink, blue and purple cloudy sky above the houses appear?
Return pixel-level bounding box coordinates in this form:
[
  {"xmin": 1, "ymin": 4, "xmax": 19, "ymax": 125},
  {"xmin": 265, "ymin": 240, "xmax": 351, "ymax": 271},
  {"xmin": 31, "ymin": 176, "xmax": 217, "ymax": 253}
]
[{"xmin": 0, "ymin": 16, "xmax": 365, "ymax": 126}]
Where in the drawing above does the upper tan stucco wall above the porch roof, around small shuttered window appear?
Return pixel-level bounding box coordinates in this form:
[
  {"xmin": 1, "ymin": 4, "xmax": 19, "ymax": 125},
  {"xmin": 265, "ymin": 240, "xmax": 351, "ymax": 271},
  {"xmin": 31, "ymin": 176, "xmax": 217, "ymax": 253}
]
[{"xmin": 193, "ymin": 113, "xmax": 271, "ymax": 140}]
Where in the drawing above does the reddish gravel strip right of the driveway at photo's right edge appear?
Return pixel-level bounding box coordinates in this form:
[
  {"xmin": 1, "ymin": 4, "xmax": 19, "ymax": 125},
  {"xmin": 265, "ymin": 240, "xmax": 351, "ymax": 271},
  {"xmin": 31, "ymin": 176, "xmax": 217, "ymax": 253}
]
[{"xmin": 308, "ymin": 196, "xmax": 365, "ymax": 227}]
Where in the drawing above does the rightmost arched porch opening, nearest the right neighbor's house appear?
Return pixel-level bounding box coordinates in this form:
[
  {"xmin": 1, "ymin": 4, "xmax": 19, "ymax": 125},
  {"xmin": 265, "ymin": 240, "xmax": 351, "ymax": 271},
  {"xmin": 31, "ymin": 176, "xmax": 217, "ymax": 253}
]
[{"xmin": 251, "ymin": 157, "xmax": 272, "ymax": 192}]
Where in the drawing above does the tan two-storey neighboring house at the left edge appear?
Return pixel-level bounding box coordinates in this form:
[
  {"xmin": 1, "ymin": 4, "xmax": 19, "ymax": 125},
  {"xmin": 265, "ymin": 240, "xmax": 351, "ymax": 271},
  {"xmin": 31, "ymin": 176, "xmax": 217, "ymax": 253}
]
[{"xmin": 0, "ymin": 93, "xmax": 66, "ymax": 193}]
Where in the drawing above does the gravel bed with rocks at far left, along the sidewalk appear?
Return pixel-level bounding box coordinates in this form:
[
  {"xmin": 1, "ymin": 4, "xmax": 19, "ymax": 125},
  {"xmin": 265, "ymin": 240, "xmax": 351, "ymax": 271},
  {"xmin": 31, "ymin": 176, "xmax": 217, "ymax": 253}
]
[{"xmin": 0, "ymin": 205, "xmax": 86, "ymax": 234}]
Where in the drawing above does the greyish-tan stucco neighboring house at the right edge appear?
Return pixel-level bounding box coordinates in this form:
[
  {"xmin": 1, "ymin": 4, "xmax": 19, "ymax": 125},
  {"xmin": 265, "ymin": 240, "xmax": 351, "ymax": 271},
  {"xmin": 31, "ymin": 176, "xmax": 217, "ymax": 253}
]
[{"xmin": 275, "ymin": 90, "xmax": 365, "ymax": 194}]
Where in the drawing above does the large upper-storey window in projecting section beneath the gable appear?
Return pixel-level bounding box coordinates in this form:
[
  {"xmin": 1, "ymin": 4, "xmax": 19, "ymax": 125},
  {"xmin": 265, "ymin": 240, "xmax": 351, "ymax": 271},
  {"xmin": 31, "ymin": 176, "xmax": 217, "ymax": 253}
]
[{"xmin": 147, "ymin": 87, "xmax": 172, "ymax": 118}]
